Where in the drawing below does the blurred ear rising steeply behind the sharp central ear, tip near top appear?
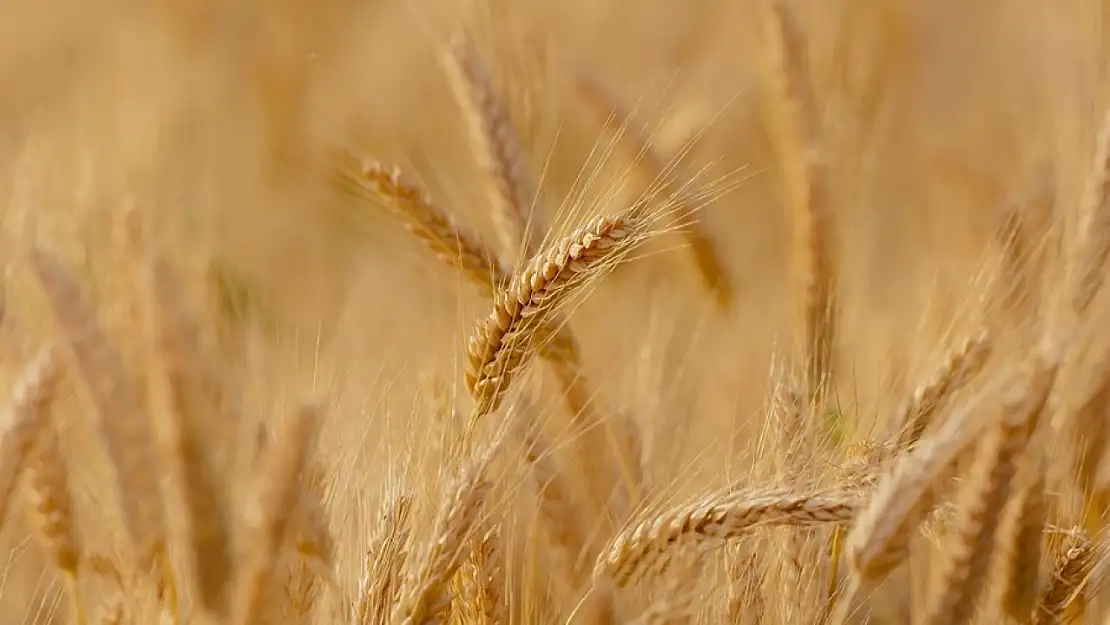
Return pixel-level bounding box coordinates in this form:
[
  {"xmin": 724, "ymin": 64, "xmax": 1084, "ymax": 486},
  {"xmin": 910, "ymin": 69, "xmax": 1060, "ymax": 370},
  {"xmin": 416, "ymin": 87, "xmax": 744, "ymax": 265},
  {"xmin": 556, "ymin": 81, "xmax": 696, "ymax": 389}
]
[{"xmin": 444, "ymin": 34, "xmax": 536, "ymax": 266}]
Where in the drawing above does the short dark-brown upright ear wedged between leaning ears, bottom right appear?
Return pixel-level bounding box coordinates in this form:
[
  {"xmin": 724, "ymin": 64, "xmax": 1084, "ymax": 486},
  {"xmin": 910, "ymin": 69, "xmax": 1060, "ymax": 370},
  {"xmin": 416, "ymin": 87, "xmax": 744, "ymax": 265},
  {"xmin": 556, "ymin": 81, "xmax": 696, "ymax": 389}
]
[{"xmin": 995, "ymin": 444, "xmax": 1048, "ymax": 623}]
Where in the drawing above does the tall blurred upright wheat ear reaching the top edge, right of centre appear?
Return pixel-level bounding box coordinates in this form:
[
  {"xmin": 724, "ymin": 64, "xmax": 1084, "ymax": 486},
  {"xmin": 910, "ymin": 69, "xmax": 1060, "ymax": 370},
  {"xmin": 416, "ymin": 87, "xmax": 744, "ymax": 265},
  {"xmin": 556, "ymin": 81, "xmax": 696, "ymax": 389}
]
[{"xmin": 760, "ymin": 0, "xmax": 836, "ymax": 405}]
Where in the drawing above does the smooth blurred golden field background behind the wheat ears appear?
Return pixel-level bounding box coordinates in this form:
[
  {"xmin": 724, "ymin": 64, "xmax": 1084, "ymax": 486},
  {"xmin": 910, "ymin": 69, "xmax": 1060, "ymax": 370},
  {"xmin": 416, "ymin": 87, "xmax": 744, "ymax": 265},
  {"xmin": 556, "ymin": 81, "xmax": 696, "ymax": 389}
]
[{"xmin": 0, "ymin": 0, "xmax": 1110, "ymax": 624}]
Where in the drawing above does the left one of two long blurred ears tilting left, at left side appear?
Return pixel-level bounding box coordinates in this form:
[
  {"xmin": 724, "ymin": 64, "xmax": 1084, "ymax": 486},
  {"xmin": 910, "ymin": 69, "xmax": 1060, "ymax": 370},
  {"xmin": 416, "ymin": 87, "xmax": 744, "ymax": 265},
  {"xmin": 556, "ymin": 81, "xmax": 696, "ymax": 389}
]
[{"xmin": 31, "ymin": 249, "xmax": 172, "ymax": 572}]
